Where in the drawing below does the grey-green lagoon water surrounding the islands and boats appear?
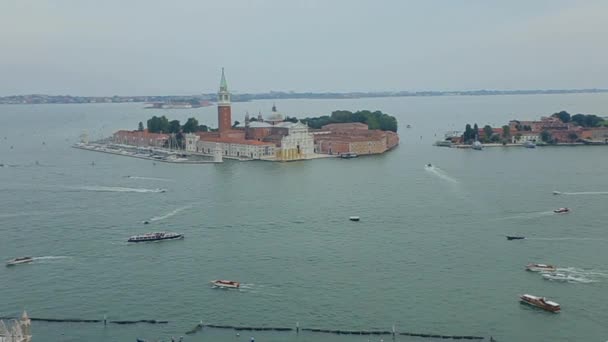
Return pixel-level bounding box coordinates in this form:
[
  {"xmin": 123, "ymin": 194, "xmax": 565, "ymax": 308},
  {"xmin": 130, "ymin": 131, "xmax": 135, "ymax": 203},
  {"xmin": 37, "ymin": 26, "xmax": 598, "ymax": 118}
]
[{"xmin": 0, "ymin": 94, "xmax": 608, "ymax": 342}]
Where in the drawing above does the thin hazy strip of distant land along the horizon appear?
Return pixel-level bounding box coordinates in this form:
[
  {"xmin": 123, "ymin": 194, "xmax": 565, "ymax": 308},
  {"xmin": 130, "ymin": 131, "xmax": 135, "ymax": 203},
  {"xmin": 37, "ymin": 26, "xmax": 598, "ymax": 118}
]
[{"xmin": 0, "ymin": 88, "xmax": 608, "ymax": 104}]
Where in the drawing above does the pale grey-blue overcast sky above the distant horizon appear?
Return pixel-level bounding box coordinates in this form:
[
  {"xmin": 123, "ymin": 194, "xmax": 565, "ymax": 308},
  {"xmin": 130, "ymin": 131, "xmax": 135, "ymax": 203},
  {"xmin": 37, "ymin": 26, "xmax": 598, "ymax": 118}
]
[{"xmin": 0, "ymin": 0, "xmax": 608, "ymax": 96}]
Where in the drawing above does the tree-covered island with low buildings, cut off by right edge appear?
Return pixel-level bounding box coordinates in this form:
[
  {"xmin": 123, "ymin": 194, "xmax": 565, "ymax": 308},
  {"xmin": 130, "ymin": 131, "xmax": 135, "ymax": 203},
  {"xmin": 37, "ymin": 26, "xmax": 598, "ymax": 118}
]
[{"xmin": 435, "ymin": 111, "xmax": 608, "ymax": 149}]
